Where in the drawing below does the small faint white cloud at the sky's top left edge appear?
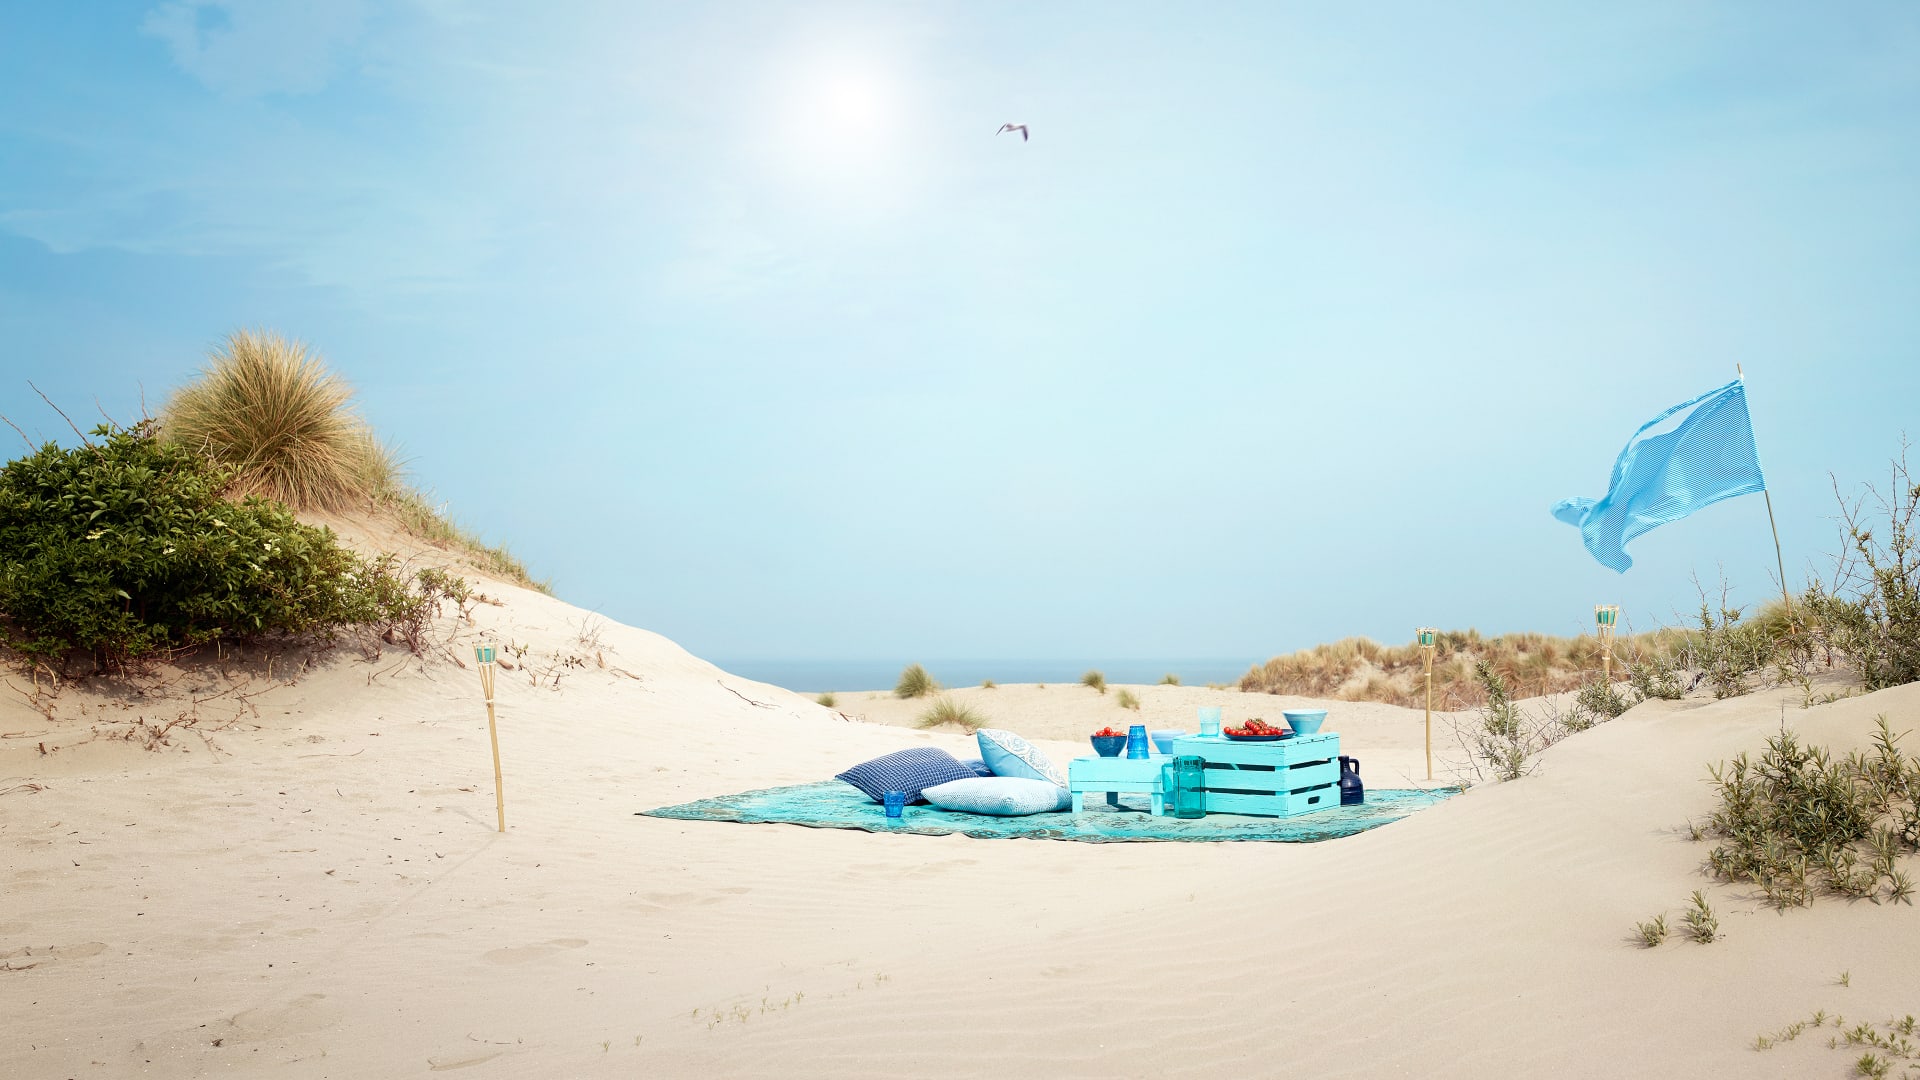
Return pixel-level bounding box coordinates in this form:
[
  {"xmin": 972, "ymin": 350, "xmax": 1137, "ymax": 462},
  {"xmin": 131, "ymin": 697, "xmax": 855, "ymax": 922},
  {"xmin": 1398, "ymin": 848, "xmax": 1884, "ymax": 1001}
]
[{"xmin": 140, "ymin": 0, "xmax": 365, "ymax": 98}]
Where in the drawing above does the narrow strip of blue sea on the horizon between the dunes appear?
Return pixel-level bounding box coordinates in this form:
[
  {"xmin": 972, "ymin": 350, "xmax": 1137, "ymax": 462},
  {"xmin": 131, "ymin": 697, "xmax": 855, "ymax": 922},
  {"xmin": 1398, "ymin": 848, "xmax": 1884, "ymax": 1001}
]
[{"xmin": 714, "ymin": 657, "xmax": 1265, "ymax": 694}]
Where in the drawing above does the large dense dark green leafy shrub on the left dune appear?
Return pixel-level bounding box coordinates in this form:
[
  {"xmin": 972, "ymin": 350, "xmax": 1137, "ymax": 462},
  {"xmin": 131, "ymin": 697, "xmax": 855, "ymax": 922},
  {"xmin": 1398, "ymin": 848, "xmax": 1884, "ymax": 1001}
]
[{"xmin": 0, "ymin": 421, "xmax": 445, "ymax": 665}]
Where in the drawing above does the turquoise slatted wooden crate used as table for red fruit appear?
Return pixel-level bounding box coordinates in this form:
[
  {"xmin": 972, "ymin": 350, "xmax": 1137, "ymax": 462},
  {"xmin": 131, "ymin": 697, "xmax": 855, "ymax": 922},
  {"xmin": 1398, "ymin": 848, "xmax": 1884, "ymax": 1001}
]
[{"xmin": 1173, "ymin": 732, "xmax": 1340, "ymax": 817}]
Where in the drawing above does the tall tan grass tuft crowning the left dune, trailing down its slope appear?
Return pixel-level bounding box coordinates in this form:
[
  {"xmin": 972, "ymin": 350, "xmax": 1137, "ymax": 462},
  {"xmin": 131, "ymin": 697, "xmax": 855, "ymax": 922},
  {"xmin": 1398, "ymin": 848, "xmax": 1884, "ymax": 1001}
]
[{"xmin": 159, "ymin": 331, "xmax": 553, "ymax": 594}]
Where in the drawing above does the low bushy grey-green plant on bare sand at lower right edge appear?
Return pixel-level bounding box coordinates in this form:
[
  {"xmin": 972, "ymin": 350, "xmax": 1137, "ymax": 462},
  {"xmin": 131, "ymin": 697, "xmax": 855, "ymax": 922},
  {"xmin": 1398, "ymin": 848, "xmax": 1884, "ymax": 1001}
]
[{"xmin": 1705, "ymin": 715, "xmax": 1920, "ymax": 909}]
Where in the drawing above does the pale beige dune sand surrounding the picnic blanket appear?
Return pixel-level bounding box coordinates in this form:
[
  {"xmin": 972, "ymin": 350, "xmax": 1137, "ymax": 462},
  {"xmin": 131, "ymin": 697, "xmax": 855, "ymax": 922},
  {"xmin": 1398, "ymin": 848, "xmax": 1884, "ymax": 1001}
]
[{"xmin": 0, "ymin": 549, "xmax": 1920, "ymax": 1078}]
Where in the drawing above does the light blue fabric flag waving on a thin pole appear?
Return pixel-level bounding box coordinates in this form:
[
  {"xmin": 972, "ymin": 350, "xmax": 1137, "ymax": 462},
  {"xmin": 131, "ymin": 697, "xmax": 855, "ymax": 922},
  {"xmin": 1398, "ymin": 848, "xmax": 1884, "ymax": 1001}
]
[{"xmin": 1553, "ymin": 379, "xmax": 1766, "ymax": 573}]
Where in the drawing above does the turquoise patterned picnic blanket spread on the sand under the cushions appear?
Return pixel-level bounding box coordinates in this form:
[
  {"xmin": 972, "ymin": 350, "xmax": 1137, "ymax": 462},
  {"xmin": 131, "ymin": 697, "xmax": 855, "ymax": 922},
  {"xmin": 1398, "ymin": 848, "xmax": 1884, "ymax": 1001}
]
[{"xmin": 636, "ymin": 780, "xmax": 1459, "ymax": 844}]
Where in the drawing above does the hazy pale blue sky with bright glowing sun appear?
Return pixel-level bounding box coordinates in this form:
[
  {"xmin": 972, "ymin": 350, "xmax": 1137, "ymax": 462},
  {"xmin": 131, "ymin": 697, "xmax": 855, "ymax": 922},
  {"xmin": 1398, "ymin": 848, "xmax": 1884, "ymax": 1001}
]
[{"xmin": 0, "ymin": 0, "xmax": 1920, "ymax": 663}]
